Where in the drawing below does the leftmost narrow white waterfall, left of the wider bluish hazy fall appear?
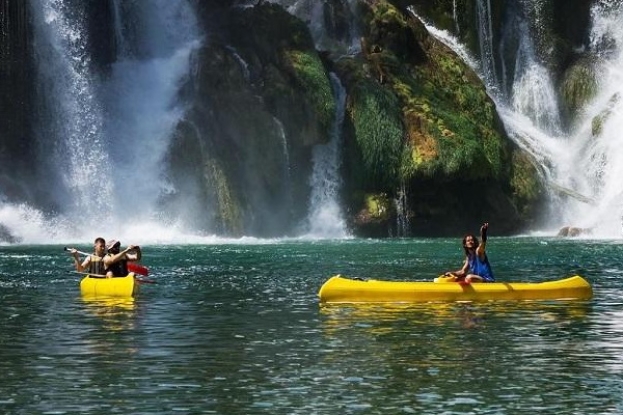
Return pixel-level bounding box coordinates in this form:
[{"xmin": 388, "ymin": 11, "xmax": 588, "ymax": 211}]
[{"xmin": 31, "ymin": 0, "xmax": 113, "ymax": 221}]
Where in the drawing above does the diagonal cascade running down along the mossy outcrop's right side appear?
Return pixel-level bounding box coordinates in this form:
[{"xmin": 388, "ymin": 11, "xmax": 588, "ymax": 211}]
[{"xmin": 411, "ymin": 0, "xmax": 588, "ymax": 234}]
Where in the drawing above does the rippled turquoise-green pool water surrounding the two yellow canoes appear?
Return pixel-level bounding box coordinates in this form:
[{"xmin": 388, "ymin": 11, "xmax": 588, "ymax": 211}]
[{"xmin": 0, "ymin": 238, "xmax": 623, "ymax": 415}]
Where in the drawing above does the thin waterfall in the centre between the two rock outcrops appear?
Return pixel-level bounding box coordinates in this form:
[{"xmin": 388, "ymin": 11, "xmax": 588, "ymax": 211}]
[{"xmin": 307, "ymin": 73, "xmax": 347, "ymax": 238}]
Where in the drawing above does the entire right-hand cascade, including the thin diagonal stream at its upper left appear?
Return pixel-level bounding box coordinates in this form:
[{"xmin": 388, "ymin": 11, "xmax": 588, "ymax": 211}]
[{"xmin": 416, "ymin": 0, "xmax": 623, "ymax": 236}]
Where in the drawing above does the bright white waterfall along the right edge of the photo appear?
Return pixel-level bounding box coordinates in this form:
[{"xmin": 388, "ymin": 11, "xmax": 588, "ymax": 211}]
[{"xmin": 555, "ymin": 2, "xmax": 623, "ymax": 237}]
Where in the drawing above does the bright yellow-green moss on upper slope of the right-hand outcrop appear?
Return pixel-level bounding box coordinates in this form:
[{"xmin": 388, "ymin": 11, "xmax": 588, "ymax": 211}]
[{"xmin": 358, "ymin": 1, "xmax": 508, "ymax": 181}]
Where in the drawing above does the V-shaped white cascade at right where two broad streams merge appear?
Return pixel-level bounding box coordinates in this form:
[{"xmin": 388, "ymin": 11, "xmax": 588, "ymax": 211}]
[{"xmin": 466, "ymin": 0, "xmax": 623, "ymax": 237}]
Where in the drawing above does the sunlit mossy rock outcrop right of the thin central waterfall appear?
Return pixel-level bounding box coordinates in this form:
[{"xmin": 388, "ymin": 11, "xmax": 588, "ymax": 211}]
[{"xmin": 334, "ymin": 1, "xmax": 543, "ymax": 236}]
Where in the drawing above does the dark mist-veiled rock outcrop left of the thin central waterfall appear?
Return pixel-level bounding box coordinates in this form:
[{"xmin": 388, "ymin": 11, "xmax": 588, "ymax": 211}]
[{"xmin": 163, "ymin": 3, "xmax": 336, "ymax": 237}]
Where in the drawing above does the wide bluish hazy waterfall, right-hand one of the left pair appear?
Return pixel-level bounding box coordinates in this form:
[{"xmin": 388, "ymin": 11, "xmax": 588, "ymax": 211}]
[{"xmin": 104, "ymin": 0, "xmax": 200, "ymax": 224}]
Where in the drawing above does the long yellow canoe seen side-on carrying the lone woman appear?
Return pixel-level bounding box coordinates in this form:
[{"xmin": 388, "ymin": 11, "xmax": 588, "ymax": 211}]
[{"xmin": 318, "ymin": 275, "xmax": 593, "ymax": 303}]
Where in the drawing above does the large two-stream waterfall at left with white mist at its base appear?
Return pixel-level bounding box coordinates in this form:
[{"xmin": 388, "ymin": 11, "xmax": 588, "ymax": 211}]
[{"xmin": 0, "ymin": 0, "xmax": 201, "ymax": 243}]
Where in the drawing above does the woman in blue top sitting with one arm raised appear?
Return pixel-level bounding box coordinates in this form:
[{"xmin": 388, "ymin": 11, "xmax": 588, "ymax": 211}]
[{"xmin": 452, "ymin": 222, "xmax": 495, "ymax": 283}]
